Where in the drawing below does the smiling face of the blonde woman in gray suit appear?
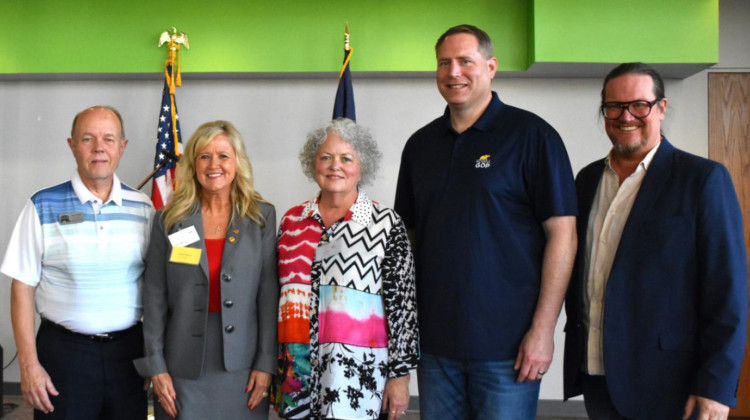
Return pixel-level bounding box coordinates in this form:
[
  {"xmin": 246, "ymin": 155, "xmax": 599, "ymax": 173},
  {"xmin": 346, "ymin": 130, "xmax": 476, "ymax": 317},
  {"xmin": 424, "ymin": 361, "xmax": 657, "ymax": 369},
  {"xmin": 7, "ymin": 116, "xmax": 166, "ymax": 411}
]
[{"xmin": 195, "ymin": 134, "xmax": 237, "ymax": 197}]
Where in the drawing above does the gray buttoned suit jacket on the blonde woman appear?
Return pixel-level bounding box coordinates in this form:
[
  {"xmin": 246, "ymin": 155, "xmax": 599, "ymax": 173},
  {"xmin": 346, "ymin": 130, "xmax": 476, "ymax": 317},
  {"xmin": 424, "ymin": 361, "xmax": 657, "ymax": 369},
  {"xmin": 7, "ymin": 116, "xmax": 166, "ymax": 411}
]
[{"xmin": 134, "ymin": 203, "xmax": 279, "ymax": 379}]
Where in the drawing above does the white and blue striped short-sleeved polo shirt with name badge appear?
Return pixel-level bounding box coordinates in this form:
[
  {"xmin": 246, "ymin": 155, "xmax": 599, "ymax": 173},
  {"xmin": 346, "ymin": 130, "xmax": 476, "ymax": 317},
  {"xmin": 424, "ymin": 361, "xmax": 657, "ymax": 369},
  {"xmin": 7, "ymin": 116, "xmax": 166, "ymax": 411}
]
[{"xmin": 0, "ymin": 172, "xmax": 153, "ymax": 334}]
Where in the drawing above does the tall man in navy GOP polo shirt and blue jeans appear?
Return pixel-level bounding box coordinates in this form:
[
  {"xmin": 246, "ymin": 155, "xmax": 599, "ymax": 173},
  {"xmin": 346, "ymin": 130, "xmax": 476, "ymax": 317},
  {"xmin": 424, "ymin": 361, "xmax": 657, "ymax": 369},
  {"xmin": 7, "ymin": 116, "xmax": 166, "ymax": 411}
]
[{"xmin": 395, "ymin": 25, "xmax": 576, "ymax": 420}]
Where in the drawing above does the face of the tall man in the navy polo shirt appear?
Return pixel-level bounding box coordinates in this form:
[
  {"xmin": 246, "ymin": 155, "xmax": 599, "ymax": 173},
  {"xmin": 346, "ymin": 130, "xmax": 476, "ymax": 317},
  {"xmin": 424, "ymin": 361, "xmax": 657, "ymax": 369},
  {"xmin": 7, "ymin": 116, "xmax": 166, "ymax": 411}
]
[{"xmin": 436, "ymin": 33, "xmax": 497, "ymax": 109}]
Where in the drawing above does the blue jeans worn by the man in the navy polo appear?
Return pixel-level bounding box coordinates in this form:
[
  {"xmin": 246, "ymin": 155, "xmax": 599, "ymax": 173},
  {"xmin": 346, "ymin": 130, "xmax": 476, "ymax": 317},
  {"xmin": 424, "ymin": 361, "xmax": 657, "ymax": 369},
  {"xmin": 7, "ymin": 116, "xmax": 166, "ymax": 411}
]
[{"xmin": 417, "ymin": 353, "xmax": 541, "ymax": 420}]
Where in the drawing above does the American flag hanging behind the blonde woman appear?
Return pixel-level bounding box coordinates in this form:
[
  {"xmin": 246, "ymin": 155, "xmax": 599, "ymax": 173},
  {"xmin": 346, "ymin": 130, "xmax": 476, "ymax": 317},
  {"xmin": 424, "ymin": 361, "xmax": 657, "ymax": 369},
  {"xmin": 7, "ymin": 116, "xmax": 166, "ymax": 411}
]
[{"xmin": 151, "ymin": 66, "xmax": 182, "ymax": 210}]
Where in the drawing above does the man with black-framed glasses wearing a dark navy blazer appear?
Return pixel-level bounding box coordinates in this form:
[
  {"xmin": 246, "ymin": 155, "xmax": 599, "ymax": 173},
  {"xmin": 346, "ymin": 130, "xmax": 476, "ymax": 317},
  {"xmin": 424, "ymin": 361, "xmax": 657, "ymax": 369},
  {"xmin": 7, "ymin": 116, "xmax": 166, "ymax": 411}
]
[{"xmin": 564, "ymin": 63, "xmax": 748, "ymax": 420}]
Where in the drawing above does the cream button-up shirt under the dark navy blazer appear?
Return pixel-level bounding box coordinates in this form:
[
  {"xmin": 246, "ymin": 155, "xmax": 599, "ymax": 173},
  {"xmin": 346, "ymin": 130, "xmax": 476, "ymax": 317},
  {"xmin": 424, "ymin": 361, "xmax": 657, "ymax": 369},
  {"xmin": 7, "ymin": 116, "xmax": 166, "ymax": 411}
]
[{"xmin": 583, "ymin": 143, "xmax": 661, "ymax": 375}]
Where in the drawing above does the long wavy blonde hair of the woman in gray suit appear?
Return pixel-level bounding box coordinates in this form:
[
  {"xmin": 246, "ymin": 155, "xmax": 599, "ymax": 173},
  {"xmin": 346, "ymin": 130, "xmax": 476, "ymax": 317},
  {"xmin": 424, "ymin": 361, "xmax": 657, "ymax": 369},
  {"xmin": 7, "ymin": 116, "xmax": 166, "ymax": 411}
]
[{"xmin": 162, "ymin": 120, "xmax": 266, "ymax": 232}]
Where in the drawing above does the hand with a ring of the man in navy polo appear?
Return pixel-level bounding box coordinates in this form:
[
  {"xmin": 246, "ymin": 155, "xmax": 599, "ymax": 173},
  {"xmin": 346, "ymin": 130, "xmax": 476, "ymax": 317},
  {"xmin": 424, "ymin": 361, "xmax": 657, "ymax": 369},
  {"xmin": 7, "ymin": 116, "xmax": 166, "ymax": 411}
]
[{"xmin": 513, "ymin": 328, "xmax": 555, "ymax": 383}]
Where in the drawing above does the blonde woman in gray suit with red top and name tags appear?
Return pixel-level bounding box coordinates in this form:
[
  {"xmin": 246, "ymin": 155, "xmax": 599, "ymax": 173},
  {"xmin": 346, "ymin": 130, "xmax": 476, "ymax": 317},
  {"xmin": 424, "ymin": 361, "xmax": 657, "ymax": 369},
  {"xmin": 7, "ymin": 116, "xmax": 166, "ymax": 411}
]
[{"xmin": 135, "ymin": 121, "xmax": 279, "ymax": 420}]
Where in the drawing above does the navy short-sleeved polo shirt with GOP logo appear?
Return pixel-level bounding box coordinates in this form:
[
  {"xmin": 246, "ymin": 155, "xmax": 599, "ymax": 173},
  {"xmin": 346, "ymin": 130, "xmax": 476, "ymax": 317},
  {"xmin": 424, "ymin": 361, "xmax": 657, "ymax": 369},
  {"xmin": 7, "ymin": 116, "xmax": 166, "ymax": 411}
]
[{"xmin": 394, "ymin": 92, "xmax": 577, "ymax": 360}]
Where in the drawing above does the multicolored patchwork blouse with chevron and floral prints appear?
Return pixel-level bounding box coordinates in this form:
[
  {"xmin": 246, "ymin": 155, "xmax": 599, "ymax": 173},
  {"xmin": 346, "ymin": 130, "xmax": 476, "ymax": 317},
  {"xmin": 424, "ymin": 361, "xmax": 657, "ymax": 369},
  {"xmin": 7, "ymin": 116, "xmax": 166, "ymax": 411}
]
[{"xmin": 272, "ymin": 191, "xmax": 419, "ymax": 419}]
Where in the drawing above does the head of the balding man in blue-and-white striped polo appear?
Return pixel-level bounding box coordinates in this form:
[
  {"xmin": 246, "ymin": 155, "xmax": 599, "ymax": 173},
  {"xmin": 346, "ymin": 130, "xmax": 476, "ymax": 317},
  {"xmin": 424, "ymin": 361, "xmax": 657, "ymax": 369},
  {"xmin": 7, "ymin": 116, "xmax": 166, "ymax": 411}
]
[{"xmin": 68, "ymin": 108, "xmax": 128, "ymax": 191}]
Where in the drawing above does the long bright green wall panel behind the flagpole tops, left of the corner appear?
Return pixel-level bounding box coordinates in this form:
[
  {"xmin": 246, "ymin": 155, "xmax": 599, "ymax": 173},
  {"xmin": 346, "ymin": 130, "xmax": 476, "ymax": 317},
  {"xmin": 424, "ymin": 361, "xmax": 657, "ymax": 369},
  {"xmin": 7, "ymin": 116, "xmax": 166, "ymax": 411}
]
[{"xmin": 0, "ymin": 0, "xmax": 528, "ymax": 74}]
